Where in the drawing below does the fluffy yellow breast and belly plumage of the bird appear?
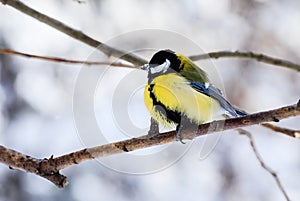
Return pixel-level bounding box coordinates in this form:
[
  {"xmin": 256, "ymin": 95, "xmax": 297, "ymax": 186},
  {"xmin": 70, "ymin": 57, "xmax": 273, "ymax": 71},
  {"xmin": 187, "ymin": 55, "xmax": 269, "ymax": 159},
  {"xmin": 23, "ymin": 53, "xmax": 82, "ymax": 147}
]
[{"xmin": 144, "ymin": 73, "xmax": 219, "ymax": 127}]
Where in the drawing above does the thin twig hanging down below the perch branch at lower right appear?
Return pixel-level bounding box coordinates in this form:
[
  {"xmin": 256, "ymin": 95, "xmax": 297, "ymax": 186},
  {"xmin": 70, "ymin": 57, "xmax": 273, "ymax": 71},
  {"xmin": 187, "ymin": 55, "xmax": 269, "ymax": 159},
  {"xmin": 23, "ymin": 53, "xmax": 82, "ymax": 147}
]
[{"xmin": 237, "ymin": 128, "xmax": 290, "ymax": 201}]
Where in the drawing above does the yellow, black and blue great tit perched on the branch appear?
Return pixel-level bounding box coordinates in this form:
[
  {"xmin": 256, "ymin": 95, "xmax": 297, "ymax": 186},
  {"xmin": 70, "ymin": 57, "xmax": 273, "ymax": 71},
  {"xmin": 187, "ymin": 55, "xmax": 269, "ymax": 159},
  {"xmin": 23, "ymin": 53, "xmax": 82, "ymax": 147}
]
[{"xmin": 141, "ymin": 49, "xmax": 247, "ymax": 143}]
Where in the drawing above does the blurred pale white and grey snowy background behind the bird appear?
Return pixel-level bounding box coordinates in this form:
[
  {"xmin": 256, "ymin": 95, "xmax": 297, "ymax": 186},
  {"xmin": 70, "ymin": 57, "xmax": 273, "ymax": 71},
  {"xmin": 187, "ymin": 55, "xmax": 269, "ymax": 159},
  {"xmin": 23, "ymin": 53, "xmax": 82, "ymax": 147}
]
[{"xmin": 0, "ymin": 0, "xmax": 300, "ymax": 201}]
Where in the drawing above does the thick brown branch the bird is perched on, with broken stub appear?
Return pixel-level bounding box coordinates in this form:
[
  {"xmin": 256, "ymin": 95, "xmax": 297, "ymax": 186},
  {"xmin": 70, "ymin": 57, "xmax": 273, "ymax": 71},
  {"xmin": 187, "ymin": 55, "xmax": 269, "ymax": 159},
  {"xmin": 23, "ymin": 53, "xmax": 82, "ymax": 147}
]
[{"xmin": 0, "ymin": 100, "xmax": 300, "ymax": 187}]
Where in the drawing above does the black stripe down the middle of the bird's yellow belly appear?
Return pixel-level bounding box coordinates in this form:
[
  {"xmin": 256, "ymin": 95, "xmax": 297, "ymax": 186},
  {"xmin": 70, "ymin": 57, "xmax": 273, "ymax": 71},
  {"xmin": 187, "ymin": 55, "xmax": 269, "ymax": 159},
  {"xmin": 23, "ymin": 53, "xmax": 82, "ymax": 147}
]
[{"xmin": 148, "ymin": 84, "xmax": 181, "ymax": 124}]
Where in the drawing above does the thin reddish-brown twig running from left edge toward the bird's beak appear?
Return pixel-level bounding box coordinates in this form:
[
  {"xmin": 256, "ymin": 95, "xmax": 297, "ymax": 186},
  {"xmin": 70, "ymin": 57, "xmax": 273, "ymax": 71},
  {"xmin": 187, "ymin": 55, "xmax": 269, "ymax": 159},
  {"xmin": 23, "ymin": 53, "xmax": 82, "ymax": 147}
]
[{"xmin": 0, "ymin": 49, "xmax": 135, "ymax": 68}]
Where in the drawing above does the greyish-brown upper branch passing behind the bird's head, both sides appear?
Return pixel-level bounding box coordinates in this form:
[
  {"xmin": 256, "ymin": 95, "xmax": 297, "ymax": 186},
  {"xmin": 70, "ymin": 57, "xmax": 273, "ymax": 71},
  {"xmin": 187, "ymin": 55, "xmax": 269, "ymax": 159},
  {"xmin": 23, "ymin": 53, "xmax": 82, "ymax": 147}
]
[{"xmin": 0, "ymin": 0, "xmax": 300, "ymax": 71}]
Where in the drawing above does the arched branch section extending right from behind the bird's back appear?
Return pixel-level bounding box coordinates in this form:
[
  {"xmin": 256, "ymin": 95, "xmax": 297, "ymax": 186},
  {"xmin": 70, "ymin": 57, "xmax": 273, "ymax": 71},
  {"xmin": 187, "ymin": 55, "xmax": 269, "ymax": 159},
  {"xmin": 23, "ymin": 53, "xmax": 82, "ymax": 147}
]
[{"xmin": 189, "ymin": 51, "xmax": 300, "ymax": 71}]
